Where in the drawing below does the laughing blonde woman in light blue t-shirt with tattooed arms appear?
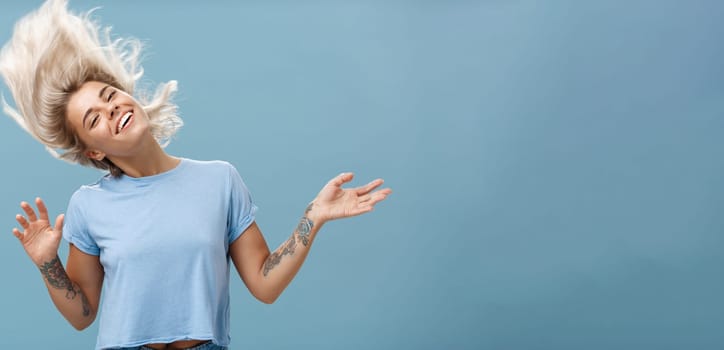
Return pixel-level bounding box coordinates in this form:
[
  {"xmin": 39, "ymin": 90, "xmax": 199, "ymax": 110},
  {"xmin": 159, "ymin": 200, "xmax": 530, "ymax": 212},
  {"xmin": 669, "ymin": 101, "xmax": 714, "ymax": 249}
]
[{"xmin": 0, "ymin": 0, "xmax": 391, "ymax": 349}]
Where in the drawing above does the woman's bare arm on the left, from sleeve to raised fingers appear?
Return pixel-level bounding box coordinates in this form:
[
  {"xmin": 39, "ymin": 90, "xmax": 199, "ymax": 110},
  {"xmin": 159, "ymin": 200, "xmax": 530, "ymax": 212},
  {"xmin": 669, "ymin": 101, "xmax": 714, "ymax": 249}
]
[{"xmin": 13, "ymin": 198, "xmax": 103, "ymax": 330}]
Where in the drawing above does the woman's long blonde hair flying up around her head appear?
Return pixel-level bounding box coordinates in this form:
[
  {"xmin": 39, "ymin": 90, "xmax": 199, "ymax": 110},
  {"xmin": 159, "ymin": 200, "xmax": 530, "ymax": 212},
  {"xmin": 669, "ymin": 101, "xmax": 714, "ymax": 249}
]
[{"xmin": 0, "ymin": 0, "xmax": 183, "ymax": 176}]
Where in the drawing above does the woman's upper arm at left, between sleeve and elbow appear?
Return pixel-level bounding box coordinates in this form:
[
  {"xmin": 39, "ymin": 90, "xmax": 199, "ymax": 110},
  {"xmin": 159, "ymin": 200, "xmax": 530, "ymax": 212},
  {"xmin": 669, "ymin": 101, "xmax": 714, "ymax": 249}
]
[{"xmin": 65, "ymin": 244, "xmax": 104, "ymax": 314}]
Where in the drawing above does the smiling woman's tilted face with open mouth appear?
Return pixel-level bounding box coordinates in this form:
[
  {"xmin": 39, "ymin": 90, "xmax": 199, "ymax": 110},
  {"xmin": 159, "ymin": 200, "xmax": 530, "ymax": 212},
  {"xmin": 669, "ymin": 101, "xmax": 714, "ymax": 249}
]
[{"xmin": 67, "ymin": 81, "xmax": 150, "ymax": 160}]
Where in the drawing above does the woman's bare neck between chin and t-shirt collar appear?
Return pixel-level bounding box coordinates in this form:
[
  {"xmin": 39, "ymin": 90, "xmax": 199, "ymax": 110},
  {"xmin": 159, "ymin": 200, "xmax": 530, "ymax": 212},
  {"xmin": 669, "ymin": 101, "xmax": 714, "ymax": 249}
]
[{"xmin": 111, "ymin": 143, "xmax": 181, "ymax": 177}]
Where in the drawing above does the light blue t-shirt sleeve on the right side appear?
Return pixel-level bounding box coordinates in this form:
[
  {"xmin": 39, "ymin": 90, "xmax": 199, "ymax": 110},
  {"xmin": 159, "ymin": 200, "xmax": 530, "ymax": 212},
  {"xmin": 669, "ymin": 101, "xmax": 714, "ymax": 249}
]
[{"xmin": 227, "ymin": 164, "xmax": 257, "ymax": 244}]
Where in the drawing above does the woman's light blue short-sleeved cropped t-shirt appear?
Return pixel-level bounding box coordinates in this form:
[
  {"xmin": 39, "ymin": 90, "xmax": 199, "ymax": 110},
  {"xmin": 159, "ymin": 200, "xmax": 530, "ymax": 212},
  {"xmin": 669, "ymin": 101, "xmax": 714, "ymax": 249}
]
[{"xmin": 63, "ymin": 159, "xmax": 256, "ymax": 349}]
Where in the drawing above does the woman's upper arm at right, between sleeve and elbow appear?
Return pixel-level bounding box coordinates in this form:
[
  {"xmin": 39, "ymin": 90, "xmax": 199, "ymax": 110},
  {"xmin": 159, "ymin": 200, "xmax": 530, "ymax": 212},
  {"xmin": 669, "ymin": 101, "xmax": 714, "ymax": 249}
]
[{"xmin": 229, "ymin": 222, "xmax": 269, "ymax": 295}]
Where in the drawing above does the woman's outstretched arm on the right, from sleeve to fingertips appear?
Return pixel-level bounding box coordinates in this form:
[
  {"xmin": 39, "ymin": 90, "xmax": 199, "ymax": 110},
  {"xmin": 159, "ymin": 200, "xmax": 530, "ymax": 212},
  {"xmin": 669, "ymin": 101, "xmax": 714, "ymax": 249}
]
[{"xmin": 229, "ymin": 173, "xmax": 392, "ymax": 303}]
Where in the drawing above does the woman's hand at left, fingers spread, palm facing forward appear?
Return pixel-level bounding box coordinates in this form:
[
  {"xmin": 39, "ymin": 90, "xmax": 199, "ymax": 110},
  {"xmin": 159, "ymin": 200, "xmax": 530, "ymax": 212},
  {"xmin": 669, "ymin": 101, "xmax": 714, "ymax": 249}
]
[{"xmin": 13, "ymin": 198, "xmax": 64, "ymax": 265}]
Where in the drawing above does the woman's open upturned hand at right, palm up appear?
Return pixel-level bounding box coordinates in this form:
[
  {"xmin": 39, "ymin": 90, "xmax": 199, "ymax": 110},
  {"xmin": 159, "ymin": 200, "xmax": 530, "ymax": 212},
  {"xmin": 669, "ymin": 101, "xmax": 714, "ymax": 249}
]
[{"xmin": 313, "ymin": 173, "xmax": 392, "ymax": 221}]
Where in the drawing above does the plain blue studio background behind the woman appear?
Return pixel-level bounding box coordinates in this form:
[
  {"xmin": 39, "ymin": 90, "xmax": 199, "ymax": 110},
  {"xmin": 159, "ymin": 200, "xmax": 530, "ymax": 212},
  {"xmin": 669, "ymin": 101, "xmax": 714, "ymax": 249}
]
[{"xmin": 0, "ymin": 0, "xmax": 724, "ymax": 349}]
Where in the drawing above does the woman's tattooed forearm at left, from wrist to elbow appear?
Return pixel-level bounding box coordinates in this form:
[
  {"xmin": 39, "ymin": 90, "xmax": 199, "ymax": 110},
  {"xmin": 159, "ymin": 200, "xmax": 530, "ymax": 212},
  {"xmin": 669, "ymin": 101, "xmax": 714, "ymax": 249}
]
[{"xmin": 38, "ymin": 255, "xmax": 96, "ymax": 330}]
